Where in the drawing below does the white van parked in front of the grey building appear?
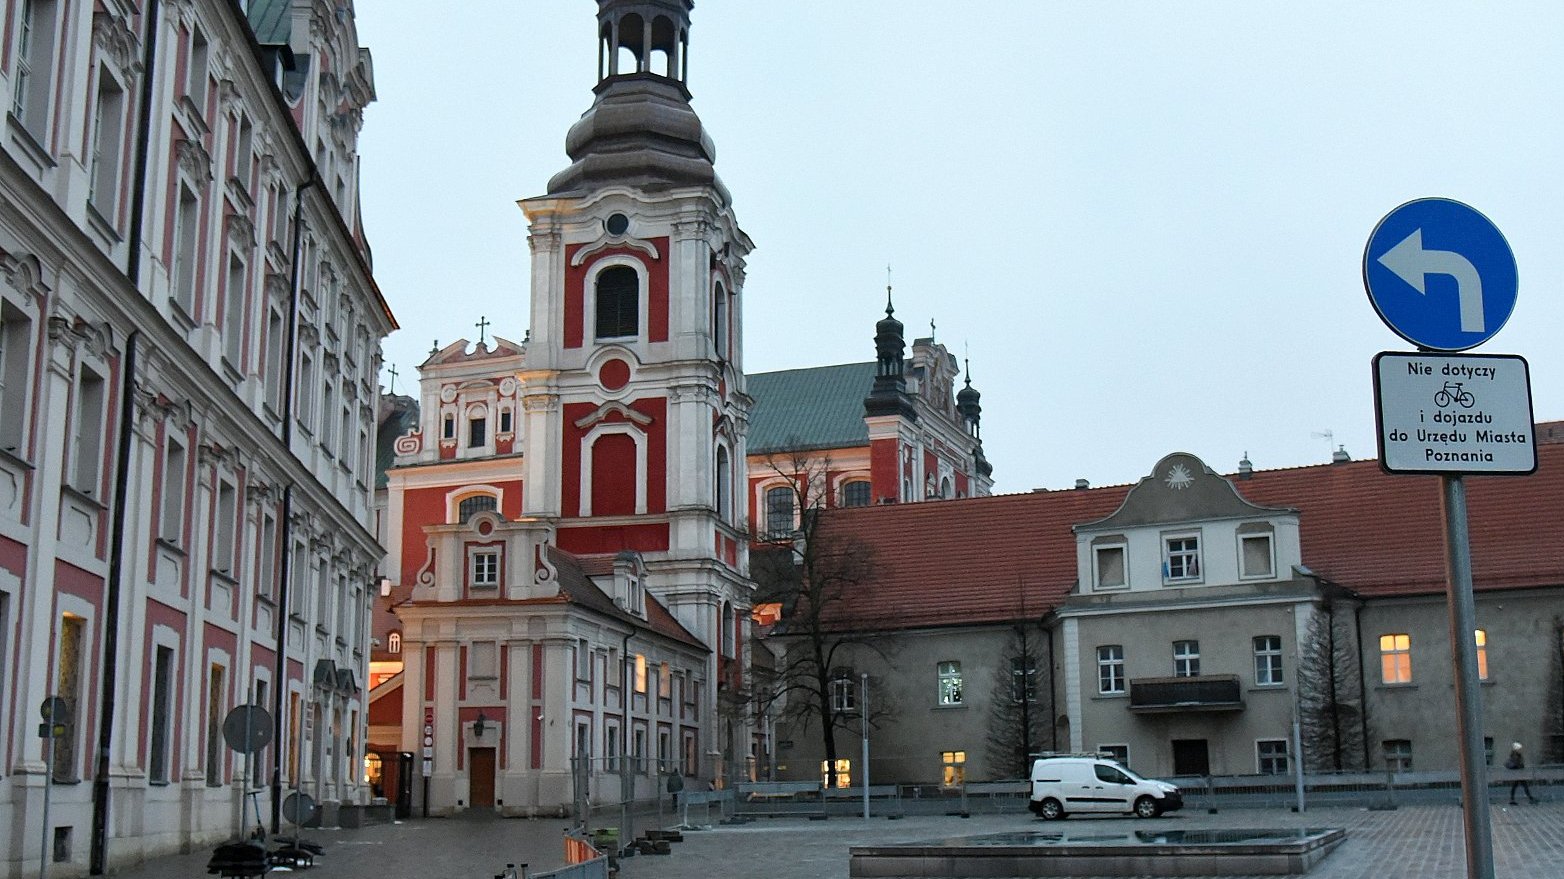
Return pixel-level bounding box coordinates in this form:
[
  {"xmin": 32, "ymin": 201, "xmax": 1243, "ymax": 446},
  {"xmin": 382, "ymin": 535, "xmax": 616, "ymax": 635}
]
[{"xmin": 1028, "ymin": 757, "xmax": 1184, "ymax": 821}]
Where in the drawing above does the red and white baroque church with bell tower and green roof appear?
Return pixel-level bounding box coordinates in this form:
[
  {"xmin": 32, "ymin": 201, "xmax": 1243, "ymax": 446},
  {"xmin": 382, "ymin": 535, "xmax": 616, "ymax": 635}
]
[{"xmin": 369, "ymin": 0, "xmax": 992, "ymax": 813}]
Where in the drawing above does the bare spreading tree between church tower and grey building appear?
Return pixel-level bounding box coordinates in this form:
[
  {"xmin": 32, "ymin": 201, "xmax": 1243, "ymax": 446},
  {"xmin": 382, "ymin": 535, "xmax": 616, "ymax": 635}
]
[{"xmin": 749, "ymin": 452, "xmax": 890, "ymax": 787}]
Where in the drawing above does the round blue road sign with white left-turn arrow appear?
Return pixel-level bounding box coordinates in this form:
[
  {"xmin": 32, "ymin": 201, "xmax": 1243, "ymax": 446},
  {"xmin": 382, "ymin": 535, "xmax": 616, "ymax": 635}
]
[{"xmin": 1364, "ymin": 199, "xmax": 1520, "ymax": 350}]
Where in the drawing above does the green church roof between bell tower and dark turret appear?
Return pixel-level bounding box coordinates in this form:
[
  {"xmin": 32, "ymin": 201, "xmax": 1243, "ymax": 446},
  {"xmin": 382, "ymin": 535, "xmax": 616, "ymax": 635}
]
[{"xmin": 748, "ymin": 363, "xmax": 874, "ymax": 455}]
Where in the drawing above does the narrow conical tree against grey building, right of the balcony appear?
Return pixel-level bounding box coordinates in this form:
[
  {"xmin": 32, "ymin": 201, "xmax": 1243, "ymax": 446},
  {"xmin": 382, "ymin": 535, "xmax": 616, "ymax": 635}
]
[{"xmin": 1298, "ymin": 601, "xmax": 1367, "ymax": 773}]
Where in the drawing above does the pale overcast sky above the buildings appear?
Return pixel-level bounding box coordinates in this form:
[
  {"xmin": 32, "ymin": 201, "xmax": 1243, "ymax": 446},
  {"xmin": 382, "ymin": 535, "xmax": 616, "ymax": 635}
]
[{"xmin": 357, "ymin": 0, "xmax": 1564, "ymax": 493}]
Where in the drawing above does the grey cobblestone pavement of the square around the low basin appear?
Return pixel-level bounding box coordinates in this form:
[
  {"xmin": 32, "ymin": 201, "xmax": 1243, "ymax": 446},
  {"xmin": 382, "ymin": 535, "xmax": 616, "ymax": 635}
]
[{"xmin": 104, "ymin": 802, "xmax": 1564, "ymax": 879}]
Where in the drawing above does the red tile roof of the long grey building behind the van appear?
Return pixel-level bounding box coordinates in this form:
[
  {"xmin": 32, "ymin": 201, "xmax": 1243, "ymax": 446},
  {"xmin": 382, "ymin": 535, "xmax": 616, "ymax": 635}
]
[{"xmin": 821, "ymin": 441, "xmax": 1564, "ymax": 629}]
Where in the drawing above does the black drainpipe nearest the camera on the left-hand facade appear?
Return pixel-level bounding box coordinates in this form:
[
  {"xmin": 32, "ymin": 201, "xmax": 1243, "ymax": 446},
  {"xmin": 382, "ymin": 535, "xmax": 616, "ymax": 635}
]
[{"xmin": 88, "ymin": 0, "xmax": 158, "ymax": 876}]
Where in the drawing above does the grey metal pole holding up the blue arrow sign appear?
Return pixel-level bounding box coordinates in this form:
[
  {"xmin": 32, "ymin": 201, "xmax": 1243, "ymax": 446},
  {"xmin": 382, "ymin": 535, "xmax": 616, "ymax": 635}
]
[{"xmin": 1440, "ymin": 475, "xmax": 1494, "ymax": 879}]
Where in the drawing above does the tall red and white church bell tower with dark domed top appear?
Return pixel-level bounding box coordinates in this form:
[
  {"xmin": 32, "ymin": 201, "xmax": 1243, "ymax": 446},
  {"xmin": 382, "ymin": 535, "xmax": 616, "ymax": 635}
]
[{"xmin": 521, "ymin": 0, "xmax": 752, "ymax": 769}]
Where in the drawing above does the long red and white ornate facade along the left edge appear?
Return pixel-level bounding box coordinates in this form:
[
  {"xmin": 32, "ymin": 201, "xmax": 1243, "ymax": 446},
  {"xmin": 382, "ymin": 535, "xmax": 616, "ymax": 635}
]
[{"xmin": 0, "ymin": 0, "xmax": 396, "ymax": 877}]
